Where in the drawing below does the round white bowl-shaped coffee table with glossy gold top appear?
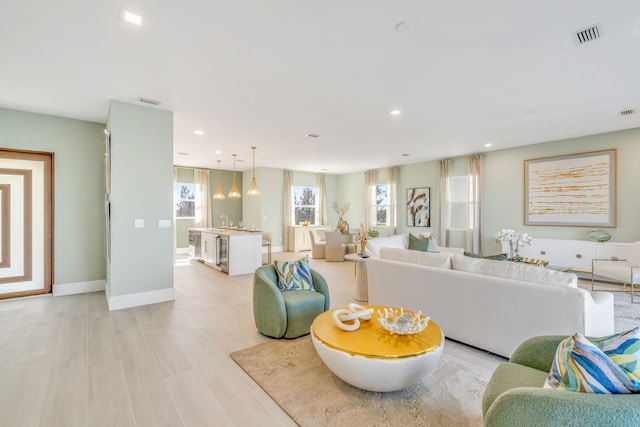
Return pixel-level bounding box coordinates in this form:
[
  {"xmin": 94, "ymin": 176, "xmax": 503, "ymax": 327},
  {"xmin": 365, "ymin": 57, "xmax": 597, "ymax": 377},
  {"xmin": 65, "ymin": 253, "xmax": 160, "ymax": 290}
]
[{"xmin": 311, "ymin": 305, "xmax": 444, "ymax": 392}]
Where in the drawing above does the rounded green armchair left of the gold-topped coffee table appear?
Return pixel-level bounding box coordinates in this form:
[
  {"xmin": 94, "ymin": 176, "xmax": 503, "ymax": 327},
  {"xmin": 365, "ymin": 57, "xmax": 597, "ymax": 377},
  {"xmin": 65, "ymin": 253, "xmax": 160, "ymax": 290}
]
[{"xmin": 253, "ymin": 264, "xmax": 330, "ymax": 338}]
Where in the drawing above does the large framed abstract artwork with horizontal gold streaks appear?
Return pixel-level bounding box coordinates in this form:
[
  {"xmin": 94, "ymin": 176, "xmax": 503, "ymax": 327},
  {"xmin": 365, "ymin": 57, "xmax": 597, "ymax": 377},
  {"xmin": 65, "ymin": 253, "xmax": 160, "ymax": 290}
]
[{"xmin": 524, "ymin": 149, "xmax": 616, "ymax": 227}]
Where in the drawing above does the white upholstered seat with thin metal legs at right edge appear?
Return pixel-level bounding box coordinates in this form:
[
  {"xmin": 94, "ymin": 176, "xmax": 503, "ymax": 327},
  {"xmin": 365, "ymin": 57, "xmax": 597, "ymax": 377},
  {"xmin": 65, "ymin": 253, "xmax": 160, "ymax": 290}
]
[{"xmin": 591, "ymin": 242, "xmax": 640, "ymax": 303}]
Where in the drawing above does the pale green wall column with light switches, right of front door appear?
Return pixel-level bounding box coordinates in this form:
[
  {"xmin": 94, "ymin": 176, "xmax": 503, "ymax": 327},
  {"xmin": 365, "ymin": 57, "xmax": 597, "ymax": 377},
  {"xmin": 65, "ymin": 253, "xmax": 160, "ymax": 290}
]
[{"xmin": 107, "ymin": 101, "xmax": 174, "ymax": 297}]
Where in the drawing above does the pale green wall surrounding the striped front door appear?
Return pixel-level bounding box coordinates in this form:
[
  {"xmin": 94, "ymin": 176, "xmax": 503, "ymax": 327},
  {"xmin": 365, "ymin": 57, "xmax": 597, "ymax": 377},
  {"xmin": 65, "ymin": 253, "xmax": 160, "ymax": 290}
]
[{"xmin": 0, "ymin": 108, "xmax": 105, "ymax": 285}]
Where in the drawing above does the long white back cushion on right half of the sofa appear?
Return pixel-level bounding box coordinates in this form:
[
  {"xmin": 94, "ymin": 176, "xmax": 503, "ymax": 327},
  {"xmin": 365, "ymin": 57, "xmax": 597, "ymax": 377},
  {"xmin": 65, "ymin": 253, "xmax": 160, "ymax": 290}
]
[{"xmin": 451, "ymin": 254, "xmax": 578, "ymax": 288}]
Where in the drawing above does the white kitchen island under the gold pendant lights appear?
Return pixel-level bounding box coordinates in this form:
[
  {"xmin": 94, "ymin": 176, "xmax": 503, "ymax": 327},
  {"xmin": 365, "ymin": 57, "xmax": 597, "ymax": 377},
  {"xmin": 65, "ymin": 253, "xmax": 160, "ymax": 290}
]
[{"xmin": 189, "ymin": 228, "xmax": 262, "ymax": 276}]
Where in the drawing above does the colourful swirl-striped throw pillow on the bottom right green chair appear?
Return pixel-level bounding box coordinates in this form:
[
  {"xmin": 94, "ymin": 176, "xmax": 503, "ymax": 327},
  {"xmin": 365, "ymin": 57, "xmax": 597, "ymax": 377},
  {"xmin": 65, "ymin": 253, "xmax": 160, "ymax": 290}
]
[{"xmin": 544, "ymin": 327, "xmax": 640, "ymax": 394}]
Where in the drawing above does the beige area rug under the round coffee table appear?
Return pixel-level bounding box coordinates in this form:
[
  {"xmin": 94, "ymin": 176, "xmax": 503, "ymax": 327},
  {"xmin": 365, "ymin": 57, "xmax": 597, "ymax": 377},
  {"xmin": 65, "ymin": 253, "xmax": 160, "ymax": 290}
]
[{"xmin": 231, "ymin": 336, "xmax": 489, "ymax": 427}]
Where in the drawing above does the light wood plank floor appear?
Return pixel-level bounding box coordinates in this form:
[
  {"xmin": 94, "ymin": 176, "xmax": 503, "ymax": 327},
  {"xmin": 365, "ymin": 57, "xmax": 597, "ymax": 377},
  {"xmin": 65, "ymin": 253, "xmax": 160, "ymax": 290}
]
[{"xmin": 0, "ymin": 253, "xmax": 504, "ymax": 427}]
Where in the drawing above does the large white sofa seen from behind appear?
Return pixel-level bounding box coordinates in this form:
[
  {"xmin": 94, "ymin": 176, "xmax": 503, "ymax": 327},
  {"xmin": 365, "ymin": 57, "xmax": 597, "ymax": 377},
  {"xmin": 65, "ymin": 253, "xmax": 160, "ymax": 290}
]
[{"xmin": 367, "ymin": 247, "xmax": 614, "ymax": 357}]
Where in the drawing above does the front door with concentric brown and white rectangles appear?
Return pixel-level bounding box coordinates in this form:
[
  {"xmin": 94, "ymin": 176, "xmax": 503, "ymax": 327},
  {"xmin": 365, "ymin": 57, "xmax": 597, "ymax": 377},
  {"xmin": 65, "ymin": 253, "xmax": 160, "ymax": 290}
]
[{"xmin": 0, "ymin": 148, "xmax": 53, "ymax": 299}]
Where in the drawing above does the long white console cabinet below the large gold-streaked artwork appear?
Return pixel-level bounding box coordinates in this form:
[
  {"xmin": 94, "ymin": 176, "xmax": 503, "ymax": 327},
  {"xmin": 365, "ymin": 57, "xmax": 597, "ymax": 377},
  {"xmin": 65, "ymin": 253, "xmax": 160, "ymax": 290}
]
[{"xmin": 502, "ymin": 238, "xmax": 631, "ymax": 273}]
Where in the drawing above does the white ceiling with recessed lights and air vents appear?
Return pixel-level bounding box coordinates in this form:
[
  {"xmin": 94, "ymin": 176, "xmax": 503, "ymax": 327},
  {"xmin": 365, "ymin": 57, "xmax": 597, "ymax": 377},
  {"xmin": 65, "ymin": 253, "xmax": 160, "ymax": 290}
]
[{"xmin": 0, "ymin": 0, "xmax": 640, "ymax": 174}]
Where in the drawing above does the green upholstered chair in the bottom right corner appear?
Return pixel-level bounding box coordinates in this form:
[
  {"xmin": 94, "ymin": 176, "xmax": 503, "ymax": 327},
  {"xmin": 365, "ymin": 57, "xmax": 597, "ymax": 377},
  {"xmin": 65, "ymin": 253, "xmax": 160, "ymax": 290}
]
[{"xmin": 482, "ymin": 336, "xmax": 640, "ymax": 427}]
